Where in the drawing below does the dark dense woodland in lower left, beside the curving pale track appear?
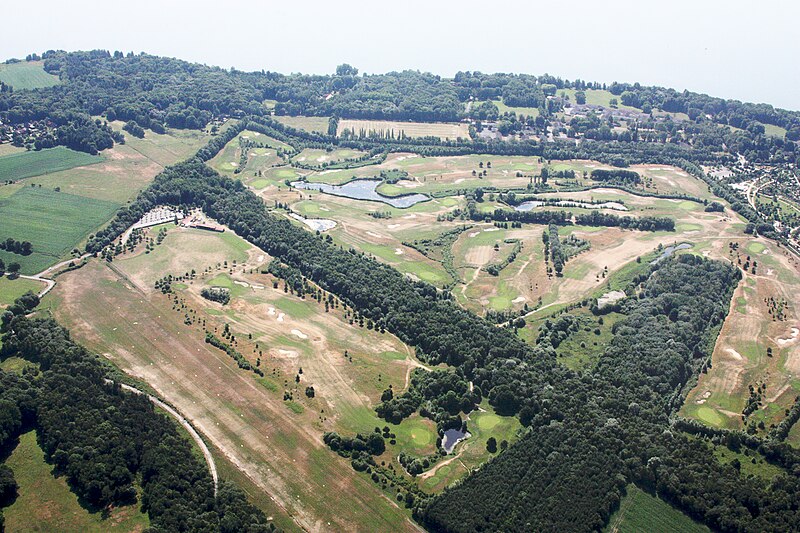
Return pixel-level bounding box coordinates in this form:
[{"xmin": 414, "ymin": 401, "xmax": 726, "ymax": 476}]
[{"xmin": 0, "ymin": 293, "xmax": 274, "ymax": 532}]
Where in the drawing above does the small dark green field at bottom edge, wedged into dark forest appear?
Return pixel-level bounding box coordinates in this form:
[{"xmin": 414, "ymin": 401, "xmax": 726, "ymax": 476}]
[{"xmin": 605, "ymin": 485, "xmax": 710, "ymax": 533}]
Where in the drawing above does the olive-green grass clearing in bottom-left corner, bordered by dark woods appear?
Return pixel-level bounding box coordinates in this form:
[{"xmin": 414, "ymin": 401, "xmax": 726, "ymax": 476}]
[{"xmin": 3, "ymin": 431, "xmax": 149, "ymax": 533}]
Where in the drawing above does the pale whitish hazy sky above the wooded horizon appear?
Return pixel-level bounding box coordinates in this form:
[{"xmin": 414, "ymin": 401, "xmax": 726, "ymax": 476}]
[{"xmin": 0, "ymin": 0, "xmax": 800, "ymax": 110}]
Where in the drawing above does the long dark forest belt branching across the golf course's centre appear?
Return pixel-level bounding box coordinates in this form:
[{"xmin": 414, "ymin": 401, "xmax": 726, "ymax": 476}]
[{"xmin": 83, "ymin": 132, "xmax": 800, "ymax": 531}]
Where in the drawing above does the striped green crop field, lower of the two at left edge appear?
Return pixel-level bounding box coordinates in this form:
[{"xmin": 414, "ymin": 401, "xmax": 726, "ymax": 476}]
[{"xmin": 0, "ymin": 187, "xmax": 119, "ymax": 274}]
